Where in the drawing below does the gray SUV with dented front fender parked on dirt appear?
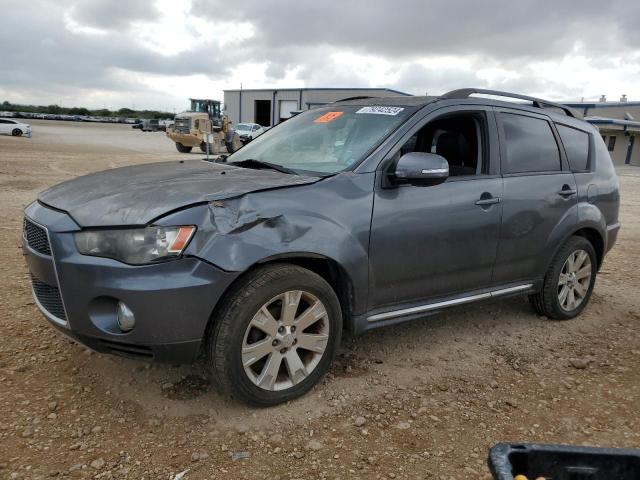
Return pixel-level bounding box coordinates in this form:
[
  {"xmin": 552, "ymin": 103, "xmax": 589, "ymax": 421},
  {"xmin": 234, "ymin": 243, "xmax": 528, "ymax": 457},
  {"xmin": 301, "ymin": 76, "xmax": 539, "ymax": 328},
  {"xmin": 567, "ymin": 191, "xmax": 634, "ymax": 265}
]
[{"xmin": 24, "ymin": 89, "xmax": 620, "ymax": 405}]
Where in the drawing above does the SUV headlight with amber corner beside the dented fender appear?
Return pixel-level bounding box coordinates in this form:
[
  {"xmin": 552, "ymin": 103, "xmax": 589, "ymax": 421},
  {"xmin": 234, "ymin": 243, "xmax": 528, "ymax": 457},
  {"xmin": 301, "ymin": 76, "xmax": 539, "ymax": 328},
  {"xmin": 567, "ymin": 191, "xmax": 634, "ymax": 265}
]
[{"xmin": 74, "ymin": 226, "xmax": 196, "ymax": 265}]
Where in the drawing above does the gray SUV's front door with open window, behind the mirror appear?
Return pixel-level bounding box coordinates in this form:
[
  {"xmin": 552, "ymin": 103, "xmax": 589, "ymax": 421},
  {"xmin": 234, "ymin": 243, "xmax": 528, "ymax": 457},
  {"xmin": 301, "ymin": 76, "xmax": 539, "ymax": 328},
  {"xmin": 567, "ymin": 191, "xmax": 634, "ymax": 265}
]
[{"xmin": 369, "ymin": 107, "xmax": 502, "ymax": 310}]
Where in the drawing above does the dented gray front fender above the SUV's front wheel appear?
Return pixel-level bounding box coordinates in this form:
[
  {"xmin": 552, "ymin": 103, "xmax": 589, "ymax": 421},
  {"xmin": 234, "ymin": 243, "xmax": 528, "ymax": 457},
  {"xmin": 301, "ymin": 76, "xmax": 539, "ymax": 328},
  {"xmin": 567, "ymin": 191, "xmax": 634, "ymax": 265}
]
[{"xmin": 163, "ymin": 173, "xmax": 374, "ymax": 313}]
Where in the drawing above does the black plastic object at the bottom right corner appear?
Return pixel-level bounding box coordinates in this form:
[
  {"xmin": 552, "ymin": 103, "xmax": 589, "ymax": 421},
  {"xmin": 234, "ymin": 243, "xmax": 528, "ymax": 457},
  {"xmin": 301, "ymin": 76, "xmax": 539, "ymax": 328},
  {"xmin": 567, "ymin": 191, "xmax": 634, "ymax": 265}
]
[{"xmin": 488, "ymin": 443, "xmax": 640, "ymax": 480}]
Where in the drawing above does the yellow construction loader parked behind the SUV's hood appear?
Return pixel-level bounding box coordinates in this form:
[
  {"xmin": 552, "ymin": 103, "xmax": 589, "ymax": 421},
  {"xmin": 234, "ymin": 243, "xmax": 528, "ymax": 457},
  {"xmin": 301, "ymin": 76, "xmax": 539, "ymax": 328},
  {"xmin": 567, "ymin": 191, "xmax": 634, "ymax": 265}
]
[{"xmin": 167, "ymin": 98, "xmax": 242, "ymax": 155}]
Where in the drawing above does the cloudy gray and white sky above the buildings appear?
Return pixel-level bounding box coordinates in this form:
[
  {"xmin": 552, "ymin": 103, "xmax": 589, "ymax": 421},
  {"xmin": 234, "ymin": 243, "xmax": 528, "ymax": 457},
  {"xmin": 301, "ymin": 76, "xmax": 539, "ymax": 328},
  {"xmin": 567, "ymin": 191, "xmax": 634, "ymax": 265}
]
[{"xmin": 0, "ymin": 0, "xmax": 640, "ymax": 111}]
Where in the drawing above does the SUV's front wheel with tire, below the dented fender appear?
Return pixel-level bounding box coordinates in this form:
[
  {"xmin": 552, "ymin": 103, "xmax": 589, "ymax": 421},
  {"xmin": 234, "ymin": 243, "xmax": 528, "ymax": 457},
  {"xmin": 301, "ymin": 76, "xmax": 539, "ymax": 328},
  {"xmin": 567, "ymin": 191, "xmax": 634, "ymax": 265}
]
[{"xmin": 208, "ymin": 264, "xmax": 342, "ymax": 406}]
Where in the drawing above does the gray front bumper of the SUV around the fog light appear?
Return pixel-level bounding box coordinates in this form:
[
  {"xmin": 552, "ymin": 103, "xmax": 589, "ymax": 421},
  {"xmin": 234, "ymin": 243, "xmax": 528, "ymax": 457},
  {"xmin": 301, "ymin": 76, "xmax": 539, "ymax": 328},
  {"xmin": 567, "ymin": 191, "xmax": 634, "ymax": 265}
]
[{"xmin": 23, "ymin": 204, "xmax": 235, "ymax": 363}]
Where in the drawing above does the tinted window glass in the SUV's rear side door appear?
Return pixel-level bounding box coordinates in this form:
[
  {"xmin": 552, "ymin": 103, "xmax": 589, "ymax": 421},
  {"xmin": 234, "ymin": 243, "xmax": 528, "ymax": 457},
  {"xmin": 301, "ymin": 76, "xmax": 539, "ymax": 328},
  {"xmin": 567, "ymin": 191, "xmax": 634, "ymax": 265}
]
[{"xmin": 501, "ymin": 113, "xmax": 560, "ymax": 173}]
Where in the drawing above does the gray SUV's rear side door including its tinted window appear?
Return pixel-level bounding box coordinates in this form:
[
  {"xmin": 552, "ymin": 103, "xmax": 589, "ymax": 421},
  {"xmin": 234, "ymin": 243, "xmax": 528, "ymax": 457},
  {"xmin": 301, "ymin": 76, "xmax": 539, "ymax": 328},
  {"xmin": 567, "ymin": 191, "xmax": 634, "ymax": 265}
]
[{"xmin": 493, "ymin": 108, "xmax": 577, "ymax": 285}]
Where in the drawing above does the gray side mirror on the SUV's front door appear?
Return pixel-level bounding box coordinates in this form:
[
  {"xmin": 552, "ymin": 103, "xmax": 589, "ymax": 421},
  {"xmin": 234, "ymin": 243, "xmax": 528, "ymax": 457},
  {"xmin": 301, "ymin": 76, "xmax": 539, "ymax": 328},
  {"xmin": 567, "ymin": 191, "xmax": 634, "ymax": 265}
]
[{"xmin": 393, "ymin": 152, "xmax": 449, "ymax": 186}]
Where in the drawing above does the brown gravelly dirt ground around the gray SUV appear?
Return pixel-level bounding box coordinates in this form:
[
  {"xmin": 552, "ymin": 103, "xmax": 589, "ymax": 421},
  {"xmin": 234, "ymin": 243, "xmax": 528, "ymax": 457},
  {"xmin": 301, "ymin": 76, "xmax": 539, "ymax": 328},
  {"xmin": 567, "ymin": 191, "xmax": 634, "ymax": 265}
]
[{"xmin": 0, "ymin": 121, "xmax": 640, "ymax": 480}]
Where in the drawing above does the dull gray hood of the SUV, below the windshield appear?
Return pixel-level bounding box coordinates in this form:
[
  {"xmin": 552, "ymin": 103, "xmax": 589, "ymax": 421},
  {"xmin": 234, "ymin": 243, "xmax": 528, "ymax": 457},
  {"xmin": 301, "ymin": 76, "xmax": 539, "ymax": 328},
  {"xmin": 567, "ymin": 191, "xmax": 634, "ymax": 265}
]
[{"xmin": 38, "ymin": 160, "xmax": 319, "ymax": 227}]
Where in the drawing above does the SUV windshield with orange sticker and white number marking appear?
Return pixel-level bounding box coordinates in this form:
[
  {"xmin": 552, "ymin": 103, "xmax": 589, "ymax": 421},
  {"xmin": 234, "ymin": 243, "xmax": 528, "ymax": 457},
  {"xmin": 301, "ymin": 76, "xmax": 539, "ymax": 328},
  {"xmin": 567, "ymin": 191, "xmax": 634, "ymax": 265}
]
[{"xmin": 227, "ymin": 105, "xmax": 413, "ymax": 174}]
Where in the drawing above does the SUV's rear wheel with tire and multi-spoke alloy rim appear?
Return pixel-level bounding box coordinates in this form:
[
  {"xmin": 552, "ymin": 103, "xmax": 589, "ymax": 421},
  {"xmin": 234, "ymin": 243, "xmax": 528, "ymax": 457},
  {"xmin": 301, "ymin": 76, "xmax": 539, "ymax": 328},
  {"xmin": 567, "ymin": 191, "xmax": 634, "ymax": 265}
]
[{"xmin": 529, "ymin": 236, "xmax": 598, "ymax": 320}]
